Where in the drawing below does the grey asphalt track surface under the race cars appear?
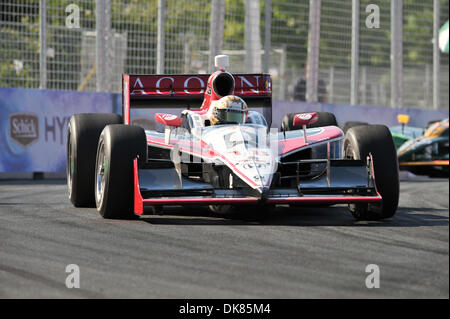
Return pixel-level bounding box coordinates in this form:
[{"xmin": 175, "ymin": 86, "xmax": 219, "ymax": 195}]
[{"xmin": 0, "ymin": 178, "xmax": 449, "ymax": 298}]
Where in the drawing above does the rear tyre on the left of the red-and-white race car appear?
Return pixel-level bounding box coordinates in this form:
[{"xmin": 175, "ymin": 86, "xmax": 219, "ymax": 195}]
[{"xmin": 66, "ymin": 113, "xmax": 122, "ymax": 207}]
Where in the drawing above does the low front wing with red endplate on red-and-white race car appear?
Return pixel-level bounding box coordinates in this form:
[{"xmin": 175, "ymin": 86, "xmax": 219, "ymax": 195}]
[{"xmin": 133, "ymin": 156, "xmax": 382, "ymax": 214}]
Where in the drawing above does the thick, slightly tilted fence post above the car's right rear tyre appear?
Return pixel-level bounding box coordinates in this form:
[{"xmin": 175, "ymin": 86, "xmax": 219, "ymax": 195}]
[{"xmin": 306, "ymin": 0, "xmax": 321, "ymax": 102}]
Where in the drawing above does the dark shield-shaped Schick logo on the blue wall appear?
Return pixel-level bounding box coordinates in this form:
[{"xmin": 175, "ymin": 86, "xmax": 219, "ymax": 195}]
[{"xmin": 9, "ymin": 113, "xmax": 39, "ymax": 147}]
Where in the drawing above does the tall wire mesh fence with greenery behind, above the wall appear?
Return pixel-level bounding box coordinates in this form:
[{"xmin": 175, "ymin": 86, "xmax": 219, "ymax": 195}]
[{"xmin": 0, "ymin": 0, "xmax": 449, "ymax": 109}]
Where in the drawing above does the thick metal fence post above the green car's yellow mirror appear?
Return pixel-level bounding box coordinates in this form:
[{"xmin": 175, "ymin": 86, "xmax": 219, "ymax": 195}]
[{"xmin": 391, "ymin": 0, "xmax": 403, "ymax": 108}]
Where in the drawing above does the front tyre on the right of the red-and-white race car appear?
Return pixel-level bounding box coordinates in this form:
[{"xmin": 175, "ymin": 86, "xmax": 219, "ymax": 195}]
[{"xmin": 344, "ymin": 125, "xmax": 400, "ymax": 220}]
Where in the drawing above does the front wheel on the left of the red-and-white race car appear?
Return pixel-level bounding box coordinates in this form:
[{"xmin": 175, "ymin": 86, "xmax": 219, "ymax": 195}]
[{"xmin": 94, "ymin": 125, "xmax": 147, "ymax": 219}]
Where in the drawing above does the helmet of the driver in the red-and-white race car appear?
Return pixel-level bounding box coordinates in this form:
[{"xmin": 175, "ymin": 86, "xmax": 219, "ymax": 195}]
[{"xmin": 211, "ymin": 95, "xmax": 248, "ymax": 125}]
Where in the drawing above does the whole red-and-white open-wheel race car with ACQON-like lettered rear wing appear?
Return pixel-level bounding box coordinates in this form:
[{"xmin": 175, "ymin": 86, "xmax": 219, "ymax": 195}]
[{"xmin": 67, "ymin": 56, "xmax": 399, "ymax": 220}]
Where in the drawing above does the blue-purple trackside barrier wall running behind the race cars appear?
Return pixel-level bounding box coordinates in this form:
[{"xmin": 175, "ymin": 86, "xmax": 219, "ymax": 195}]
[{"xmin": 0, "ymin": 88, "xmax": 449, "ymax": 179}]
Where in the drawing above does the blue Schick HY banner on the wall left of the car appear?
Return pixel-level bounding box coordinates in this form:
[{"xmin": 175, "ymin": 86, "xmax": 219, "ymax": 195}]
[{"xmin": 0, "ymin": 88, "xmax": 113, "ymax": 172}]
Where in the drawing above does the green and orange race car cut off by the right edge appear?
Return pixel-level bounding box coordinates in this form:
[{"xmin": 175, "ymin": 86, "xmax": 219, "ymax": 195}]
[{"xmin": 398, "ymin": 119, "xmax": 449, "ymax": 177}]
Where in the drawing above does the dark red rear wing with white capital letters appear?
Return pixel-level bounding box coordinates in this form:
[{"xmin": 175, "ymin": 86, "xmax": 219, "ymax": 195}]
[{"xmin": 122, "ymin": 74, "xmax": 272, "ymax": 124}]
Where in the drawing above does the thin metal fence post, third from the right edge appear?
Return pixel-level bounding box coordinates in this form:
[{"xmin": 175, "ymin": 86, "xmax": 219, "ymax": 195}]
[{"xmin": 350, "ymin": 0, "xmax": 359, "ymax": 105}]
